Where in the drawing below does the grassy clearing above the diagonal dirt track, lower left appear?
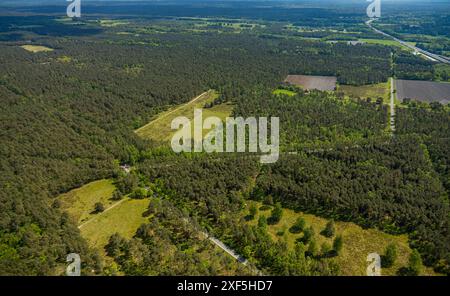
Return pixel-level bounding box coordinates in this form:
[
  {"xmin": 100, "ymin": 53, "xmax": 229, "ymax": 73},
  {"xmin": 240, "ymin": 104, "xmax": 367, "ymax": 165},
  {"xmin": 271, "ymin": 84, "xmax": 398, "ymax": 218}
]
[{"xmin": 58, "ymin": 180, "xmax": 116, "ymax": 224}]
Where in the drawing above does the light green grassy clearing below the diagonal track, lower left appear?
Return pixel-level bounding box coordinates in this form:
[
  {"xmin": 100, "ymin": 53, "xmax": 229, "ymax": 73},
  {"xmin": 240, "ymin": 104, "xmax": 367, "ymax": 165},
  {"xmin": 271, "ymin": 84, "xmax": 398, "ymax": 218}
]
[{"xmin": 81, "ymin": 199, "xmax": 150, "ymax": 255}]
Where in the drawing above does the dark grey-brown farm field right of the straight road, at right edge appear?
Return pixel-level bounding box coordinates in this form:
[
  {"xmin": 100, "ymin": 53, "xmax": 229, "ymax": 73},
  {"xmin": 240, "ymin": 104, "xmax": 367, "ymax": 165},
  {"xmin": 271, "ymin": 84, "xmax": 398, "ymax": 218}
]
[{"xmin": 395, "ymin": 79, "xmax": 450, "ymax": 104}]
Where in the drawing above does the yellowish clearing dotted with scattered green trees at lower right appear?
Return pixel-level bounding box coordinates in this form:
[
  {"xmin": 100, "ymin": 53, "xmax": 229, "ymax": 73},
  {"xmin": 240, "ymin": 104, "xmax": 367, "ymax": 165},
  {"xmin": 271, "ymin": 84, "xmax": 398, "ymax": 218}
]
[{"xmin": 244, "ymin": 201, "xmax": 434, "ymax": 276}]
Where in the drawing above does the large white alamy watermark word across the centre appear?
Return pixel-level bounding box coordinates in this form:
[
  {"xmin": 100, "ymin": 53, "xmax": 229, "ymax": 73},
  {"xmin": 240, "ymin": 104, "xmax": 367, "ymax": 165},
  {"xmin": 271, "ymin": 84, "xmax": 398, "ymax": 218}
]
[{"xmin": 171, "ymin": 109, "xmax": 280, "ymax": 163}]
